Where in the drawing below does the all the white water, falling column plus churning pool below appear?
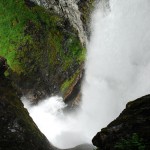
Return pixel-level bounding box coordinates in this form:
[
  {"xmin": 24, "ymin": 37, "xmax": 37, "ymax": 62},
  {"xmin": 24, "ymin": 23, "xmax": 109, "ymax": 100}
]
[{"xmin": 22, "ymin": 0, "xmax": 150, "ymax": 148}]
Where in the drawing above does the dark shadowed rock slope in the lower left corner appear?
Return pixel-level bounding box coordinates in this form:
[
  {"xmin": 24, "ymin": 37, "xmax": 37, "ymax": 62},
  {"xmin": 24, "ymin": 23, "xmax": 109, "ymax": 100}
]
[{"xmin": 0, "ymin": 57, "xmax": 55, "ymax": 150}]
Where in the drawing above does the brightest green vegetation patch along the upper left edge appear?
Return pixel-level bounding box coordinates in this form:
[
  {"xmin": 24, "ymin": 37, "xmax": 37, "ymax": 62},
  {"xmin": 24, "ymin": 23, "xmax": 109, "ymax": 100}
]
[{"xmin": 0, "ymin": 0, "xmax": 35, "ymax": 73}]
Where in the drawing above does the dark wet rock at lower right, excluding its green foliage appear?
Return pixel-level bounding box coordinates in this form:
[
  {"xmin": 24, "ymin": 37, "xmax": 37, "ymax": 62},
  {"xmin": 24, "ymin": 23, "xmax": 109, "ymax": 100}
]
[{"xmin": 92, "ymin": 95, "xmax": 150, "ymax": 150}]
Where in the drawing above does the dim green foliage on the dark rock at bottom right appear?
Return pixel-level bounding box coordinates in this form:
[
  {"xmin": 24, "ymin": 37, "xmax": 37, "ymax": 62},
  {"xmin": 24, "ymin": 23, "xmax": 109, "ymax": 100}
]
[{"xmin": 115, "ymin": 133, "xmax": 145, "ymax": 150}]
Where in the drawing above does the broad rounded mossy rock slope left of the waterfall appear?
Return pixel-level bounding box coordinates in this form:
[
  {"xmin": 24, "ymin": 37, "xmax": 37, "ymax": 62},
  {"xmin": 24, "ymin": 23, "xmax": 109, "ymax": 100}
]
[{"xmin": 0, "ymin": 0, "xmax": 85, "ymax": 102}]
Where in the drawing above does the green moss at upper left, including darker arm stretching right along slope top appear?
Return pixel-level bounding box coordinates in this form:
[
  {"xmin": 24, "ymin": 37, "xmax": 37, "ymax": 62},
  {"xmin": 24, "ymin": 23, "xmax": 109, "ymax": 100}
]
[{"xmin": 0, "ymin": 0, "xmax": 62, "ymax": 73}]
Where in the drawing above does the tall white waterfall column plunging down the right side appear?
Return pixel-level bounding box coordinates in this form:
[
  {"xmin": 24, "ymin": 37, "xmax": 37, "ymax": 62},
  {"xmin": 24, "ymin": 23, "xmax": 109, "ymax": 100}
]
[{"xmin": 82, "ymin": 0, "xmax": 150, "ymax": 135}]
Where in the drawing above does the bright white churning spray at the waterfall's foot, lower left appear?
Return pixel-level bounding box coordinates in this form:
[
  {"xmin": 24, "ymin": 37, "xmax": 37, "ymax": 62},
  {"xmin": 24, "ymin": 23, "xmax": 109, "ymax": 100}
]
[{"xmin": 22, "ymin": 96, "xmax": 88, "ymax": 148}]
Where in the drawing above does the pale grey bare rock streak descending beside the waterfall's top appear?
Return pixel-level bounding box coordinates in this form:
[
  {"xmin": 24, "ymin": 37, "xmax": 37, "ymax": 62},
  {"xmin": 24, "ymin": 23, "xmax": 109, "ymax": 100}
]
[{"xmin": 32, "ymin": 0, "xmax": 86, "ymax": 43}]
